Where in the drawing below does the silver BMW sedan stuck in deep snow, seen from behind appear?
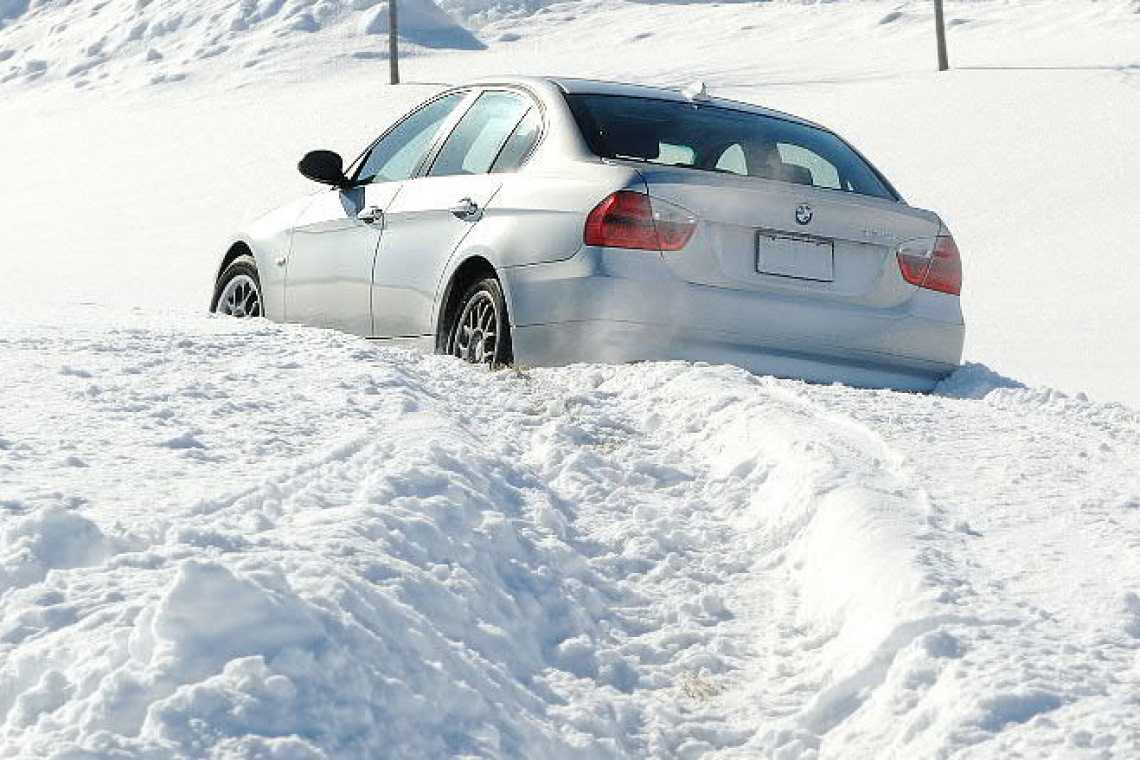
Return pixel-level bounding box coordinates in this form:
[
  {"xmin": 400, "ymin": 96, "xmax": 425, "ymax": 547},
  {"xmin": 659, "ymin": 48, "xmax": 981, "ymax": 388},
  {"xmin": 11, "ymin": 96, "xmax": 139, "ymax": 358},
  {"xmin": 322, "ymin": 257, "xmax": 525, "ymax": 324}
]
[{"xmin": 211, "ymin": 77, "xmax": 964, "ymax": 390}]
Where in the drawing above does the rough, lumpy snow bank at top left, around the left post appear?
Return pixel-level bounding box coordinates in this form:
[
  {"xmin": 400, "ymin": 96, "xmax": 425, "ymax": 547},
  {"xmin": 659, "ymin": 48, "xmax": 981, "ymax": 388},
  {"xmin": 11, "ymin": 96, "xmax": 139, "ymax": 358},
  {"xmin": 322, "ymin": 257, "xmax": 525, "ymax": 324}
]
[{"xmin": 0, "ymin": 0, "xmax": 485, "ymax": 88}]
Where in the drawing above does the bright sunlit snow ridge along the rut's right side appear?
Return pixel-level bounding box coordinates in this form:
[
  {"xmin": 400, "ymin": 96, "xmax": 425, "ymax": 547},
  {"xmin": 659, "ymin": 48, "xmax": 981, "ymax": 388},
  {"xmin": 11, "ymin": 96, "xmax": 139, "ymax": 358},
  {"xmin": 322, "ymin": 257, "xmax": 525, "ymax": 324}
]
[{"xmin": 549, "ymin": 367, "xmax": 1008, "ymax": 754}]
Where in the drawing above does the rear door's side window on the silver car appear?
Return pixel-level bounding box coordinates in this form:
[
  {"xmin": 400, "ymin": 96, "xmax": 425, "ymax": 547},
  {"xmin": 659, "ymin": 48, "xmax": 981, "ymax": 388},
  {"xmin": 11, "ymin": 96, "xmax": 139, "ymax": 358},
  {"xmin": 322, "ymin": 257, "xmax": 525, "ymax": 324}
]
[{"xmin": 428, "ymin": 92, "xmax": 530, "ymax": 177}]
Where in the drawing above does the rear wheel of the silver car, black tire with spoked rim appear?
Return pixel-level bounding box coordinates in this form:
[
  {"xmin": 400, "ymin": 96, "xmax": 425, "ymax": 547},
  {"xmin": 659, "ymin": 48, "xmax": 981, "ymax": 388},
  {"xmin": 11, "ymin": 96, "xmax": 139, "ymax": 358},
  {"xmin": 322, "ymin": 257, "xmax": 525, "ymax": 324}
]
[{"xmin": 447, "ymin": 277, "xmax": 514, "ymax": 369}]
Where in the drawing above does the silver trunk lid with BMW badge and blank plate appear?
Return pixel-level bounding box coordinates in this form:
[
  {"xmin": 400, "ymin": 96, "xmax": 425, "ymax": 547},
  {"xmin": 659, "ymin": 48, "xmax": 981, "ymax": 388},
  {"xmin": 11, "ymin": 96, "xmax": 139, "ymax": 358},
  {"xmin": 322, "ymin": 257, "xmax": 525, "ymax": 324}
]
[{"xmin": 630, "ymin": 162, "xmax": 941, "ymax": 307}]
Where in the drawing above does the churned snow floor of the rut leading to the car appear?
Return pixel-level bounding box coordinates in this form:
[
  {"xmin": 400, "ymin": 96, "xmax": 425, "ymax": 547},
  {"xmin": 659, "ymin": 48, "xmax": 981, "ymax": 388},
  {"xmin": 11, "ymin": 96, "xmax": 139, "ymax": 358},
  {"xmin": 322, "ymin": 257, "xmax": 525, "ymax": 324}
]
[{"xmin": 515, "ymin": 366, "xmax": 770, "ymax": 757}]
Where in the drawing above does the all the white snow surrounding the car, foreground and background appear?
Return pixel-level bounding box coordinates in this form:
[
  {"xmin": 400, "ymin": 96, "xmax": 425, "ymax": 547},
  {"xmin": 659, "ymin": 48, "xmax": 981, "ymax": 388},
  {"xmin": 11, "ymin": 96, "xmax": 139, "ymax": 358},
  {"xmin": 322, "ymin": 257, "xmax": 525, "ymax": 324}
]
[{"xmin": 0, "ymin": 0, "xmax": 1140, "ymax": 759}]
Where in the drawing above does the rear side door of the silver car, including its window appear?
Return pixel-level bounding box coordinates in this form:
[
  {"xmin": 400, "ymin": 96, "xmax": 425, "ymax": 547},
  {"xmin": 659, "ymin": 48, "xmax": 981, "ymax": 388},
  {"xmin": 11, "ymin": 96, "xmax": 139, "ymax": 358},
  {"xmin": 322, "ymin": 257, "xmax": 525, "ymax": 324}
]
[{"xmin": 372, "ymin": 90, "xmax": 536, "ymax": 337}]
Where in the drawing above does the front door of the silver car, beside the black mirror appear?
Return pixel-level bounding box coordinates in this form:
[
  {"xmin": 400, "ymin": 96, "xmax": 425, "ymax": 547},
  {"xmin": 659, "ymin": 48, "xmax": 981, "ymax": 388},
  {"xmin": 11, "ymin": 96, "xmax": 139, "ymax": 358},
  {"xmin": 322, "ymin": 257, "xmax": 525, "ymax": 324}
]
[{"xmin": 285, "ymin": 91, "xmax": 467, "ymax": 335}]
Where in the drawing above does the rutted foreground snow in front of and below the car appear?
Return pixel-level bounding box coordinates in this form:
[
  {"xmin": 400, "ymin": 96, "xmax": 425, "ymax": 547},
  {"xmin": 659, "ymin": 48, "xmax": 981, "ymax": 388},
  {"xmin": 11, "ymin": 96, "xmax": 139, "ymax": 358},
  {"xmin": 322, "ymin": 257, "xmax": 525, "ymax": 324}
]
[{"xmin": 0, "ymin": 307, "xmax": 1140, "ymax": 758}]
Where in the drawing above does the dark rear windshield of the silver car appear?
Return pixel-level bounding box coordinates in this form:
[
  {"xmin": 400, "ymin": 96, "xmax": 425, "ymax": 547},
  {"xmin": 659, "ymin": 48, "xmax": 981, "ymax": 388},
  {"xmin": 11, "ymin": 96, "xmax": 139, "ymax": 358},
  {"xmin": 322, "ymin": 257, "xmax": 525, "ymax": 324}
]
[{"xmin": 567, "ymin": 95, "xmax": 897, "ymax": 201}]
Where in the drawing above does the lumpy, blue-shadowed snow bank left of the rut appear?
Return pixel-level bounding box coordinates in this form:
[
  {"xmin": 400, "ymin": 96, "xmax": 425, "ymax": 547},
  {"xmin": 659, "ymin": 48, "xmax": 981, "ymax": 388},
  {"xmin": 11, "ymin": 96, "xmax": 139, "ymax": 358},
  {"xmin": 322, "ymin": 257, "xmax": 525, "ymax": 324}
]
[{"xmin": 0, "ymin": 415, "xmax": 605, "ymax": 758}]
